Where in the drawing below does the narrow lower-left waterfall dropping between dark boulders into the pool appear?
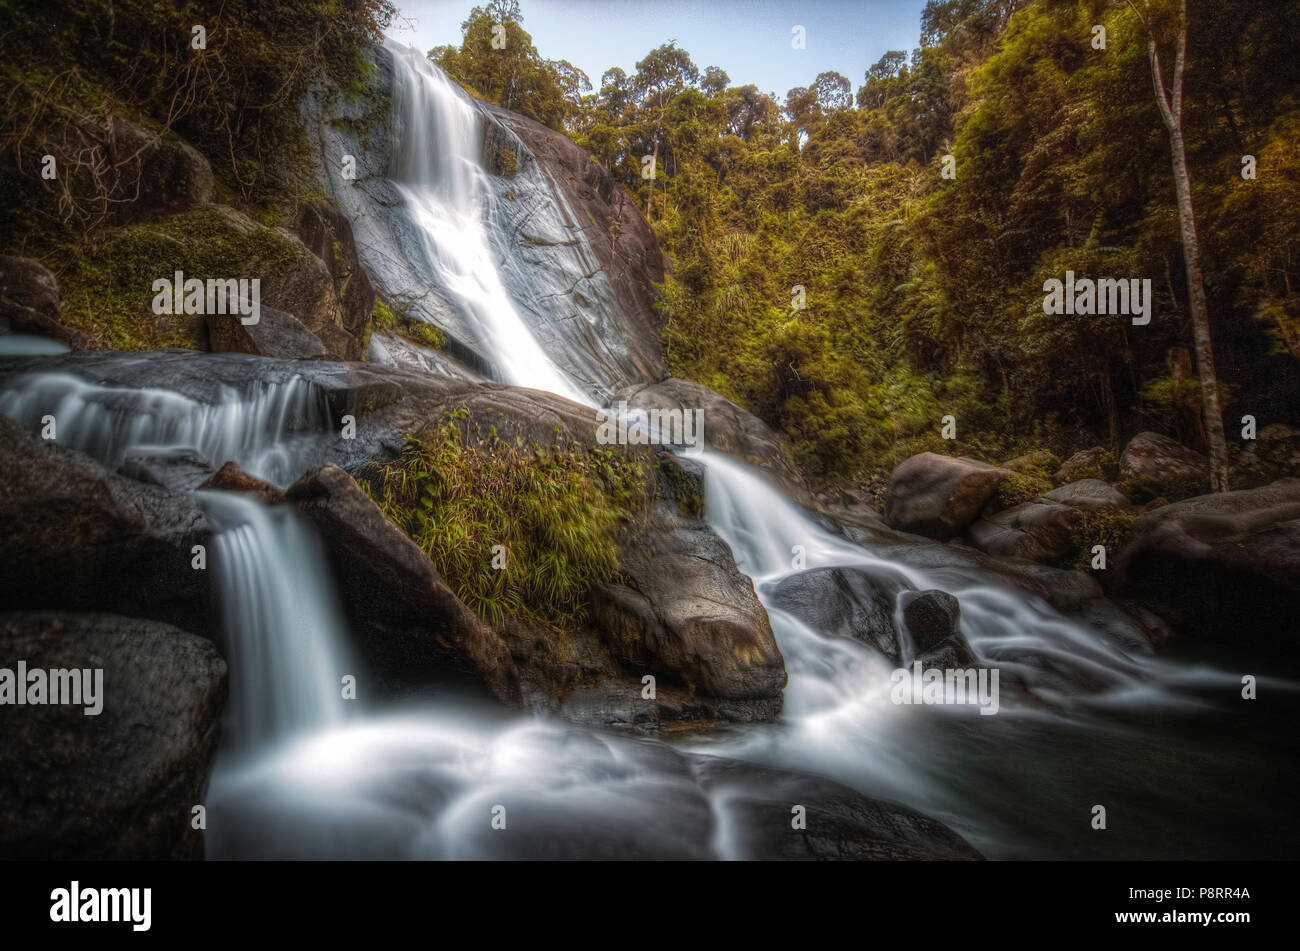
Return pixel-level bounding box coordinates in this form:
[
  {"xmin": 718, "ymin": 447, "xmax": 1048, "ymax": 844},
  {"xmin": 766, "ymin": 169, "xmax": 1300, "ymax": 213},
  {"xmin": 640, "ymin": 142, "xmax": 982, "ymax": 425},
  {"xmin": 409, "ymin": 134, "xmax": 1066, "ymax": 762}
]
[{"xmin": 198, "ymin": 491, "xmax": 351, "ymax": 748}]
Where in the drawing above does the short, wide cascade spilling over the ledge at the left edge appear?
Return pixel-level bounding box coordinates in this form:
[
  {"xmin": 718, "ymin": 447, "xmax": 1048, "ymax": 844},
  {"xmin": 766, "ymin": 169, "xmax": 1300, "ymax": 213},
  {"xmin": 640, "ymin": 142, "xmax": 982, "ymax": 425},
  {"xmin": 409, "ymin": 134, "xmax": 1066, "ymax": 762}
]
[{"xmin": 0, "ymin": 372, "xmax": 330, "ymax": 485}]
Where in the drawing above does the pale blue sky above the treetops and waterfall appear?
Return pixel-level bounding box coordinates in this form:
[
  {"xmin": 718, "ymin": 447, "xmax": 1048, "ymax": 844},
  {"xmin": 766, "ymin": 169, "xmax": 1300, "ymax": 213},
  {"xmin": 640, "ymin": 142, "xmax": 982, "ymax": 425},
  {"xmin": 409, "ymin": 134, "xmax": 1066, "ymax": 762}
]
[{"xmin": 389, "ymin": 0, "xmax": 926, "ymax": 100}]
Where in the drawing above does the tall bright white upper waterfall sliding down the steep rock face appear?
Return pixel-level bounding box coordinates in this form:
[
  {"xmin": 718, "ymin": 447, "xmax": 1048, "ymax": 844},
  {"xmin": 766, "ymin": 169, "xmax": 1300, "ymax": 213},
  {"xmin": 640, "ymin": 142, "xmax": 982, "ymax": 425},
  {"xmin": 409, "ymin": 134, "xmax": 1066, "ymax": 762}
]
[{"xmin": 386, "ymin": 40, "xmax": 590, "ymax": 403}]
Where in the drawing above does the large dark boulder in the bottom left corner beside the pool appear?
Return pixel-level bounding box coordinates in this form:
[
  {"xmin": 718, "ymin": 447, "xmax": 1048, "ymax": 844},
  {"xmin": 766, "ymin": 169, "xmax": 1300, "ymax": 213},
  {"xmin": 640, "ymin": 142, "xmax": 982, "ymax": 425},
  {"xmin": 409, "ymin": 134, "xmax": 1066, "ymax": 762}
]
[{"xmin": 0, "ymin": 611, "xmax": 228, "ymax": 861}]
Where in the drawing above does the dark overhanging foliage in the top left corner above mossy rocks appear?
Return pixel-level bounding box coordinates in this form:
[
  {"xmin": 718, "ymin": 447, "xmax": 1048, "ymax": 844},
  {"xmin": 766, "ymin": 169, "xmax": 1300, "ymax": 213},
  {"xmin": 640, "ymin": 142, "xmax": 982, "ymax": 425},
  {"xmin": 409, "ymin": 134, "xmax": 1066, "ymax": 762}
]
[{"xmin": 0, "ymin": 0, "xmax": 394, "ymax": 251}]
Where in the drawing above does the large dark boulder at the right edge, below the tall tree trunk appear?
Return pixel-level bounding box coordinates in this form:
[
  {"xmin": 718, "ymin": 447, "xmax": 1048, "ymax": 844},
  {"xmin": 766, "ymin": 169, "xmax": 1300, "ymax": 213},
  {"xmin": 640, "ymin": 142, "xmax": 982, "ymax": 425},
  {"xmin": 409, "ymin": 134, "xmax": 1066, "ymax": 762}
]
[{"xmin": 1105, "ymin": 479, "xmax": 1300, "ymax": 650}]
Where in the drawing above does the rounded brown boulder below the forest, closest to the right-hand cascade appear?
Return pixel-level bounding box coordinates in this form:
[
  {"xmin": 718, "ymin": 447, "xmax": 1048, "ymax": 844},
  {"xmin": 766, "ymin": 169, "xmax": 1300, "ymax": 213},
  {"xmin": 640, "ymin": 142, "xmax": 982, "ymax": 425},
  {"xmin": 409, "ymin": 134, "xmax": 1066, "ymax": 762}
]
[{"xmin": 885, "ymin": 452, "xmax": 1010, "ymax": 540}]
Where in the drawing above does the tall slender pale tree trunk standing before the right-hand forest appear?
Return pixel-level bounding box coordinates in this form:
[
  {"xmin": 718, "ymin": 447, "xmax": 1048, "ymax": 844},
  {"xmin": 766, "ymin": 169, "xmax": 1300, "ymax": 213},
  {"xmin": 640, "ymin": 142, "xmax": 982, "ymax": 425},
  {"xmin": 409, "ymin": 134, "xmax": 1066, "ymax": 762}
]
[{"xmin": 1147, "ymin": 0, "xmax": 1229, "ymax": 492}]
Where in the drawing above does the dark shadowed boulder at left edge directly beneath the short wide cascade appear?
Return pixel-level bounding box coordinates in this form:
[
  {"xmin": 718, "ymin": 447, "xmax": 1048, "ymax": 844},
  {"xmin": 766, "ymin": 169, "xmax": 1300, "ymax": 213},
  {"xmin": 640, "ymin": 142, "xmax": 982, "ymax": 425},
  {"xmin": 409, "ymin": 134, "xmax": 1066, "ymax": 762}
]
[{"xmin": 0, "ymin": 417, "xmax": 211, "ymax": 634}]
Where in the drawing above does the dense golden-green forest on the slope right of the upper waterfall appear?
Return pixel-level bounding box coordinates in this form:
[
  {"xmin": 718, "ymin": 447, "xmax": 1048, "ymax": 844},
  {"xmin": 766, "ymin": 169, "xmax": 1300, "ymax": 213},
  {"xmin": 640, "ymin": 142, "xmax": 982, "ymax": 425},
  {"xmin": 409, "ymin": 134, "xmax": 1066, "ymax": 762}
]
[{"xmin": 436, "ymin": 0, "xmax": 1300, "ymax": 478}]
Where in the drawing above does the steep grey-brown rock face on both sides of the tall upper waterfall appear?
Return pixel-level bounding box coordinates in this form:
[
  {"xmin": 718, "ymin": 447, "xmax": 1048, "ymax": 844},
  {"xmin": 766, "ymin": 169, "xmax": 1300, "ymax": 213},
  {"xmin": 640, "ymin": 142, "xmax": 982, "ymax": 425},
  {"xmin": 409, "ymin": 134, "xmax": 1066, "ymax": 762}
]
[{"xmin": 309, "ymin": 42, "xmax": 664, "ymax": 396}]
